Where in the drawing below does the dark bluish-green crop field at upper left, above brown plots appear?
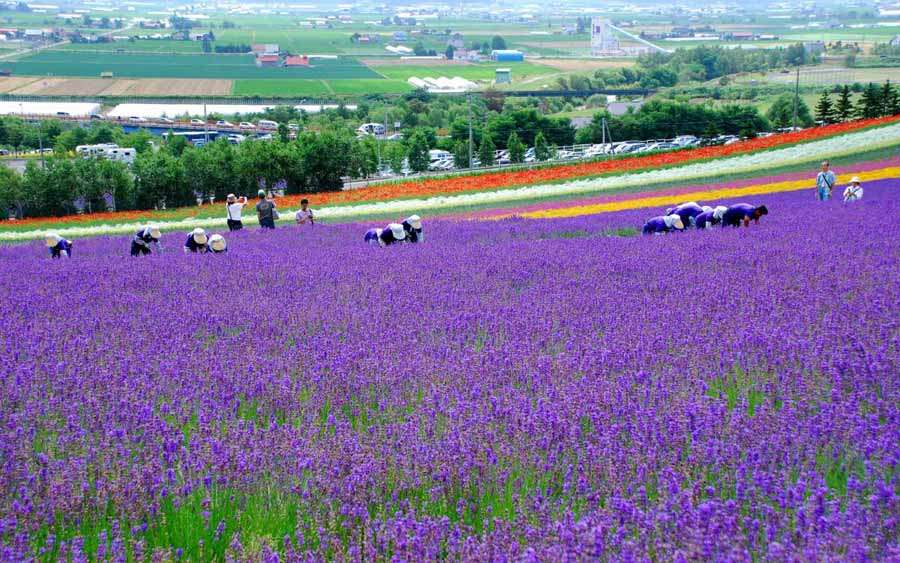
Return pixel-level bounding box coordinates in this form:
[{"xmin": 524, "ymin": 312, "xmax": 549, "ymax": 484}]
[{"xmin": 4, "ymin": 51, "xmax": 379, "ymax": 79}]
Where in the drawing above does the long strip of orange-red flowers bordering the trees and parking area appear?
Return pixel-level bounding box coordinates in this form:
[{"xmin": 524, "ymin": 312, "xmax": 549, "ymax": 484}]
[{"xmin": 8, "ymin": 117, "xmax": 900, "ymax": 226}]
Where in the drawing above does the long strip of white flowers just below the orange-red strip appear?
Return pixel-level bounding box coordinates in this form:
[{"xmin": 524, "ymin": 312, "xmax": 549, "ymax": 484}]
[{"xmin": 7, "ymin": 124, "xmax": 900, "ymax": 241}]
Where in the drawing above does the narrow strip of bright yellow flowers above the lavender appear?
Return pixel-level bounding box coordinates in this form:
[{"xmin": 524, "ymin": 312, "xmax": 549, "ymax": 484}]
[{"xmin": 484, "ymin": 167, "xmax": 900, "ymax": 220}]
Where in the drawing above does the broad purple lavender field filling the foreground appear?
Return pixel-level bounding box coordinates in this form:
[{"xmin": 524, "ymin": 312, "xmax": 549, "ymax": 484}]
[{"xmin": 0, "ymin": 182, "xmax": 900, "ymax": 562}]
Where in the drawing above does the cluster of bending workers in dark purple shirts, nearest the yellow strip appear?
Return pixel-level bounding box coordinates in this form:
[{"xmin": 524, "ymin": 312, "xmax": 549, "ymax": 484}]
[{"xmin": 641, "ymin": 201, "xmax": 769, "ymax": 235}]
